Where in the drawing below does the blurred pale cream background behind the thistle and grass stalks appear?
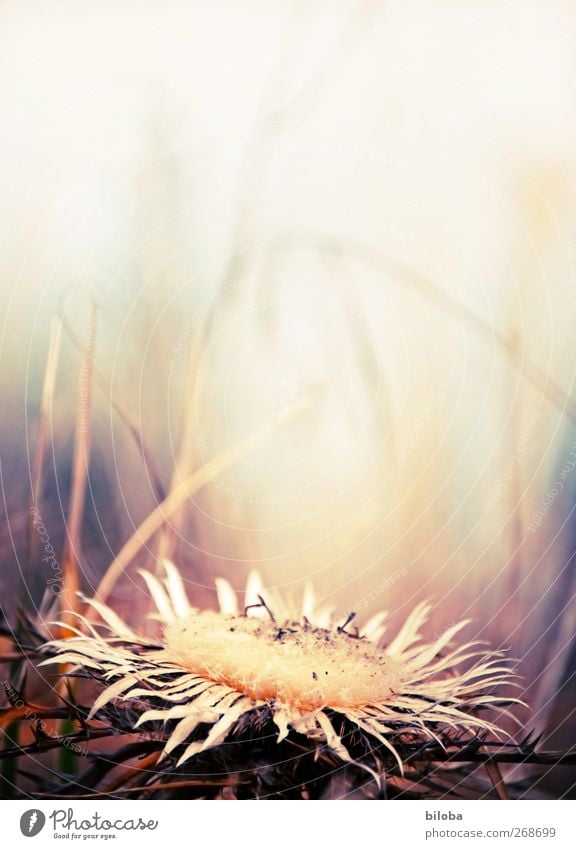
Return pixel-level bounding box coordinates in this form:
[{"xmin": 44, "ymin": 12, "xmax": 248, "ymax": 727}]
[{"xmin": 0, "ymin": 0, "xmax": 576, "ymax": 776}]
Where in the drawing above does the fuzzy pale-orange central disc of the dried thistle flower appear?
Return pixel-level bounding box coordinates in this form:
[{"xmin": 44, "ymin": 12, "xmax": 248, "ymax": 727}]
[{"xmin": 160, "ymin": 612, "xmax": 401, "ymax": 711}]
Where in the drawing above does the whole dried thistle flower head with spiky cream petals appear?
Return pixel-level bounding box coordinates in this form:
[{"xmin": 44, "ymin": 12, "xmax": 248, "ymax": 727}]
[{"xmin": 43, "ymin": 562, "xmax": 515, "ymax": 778}]
